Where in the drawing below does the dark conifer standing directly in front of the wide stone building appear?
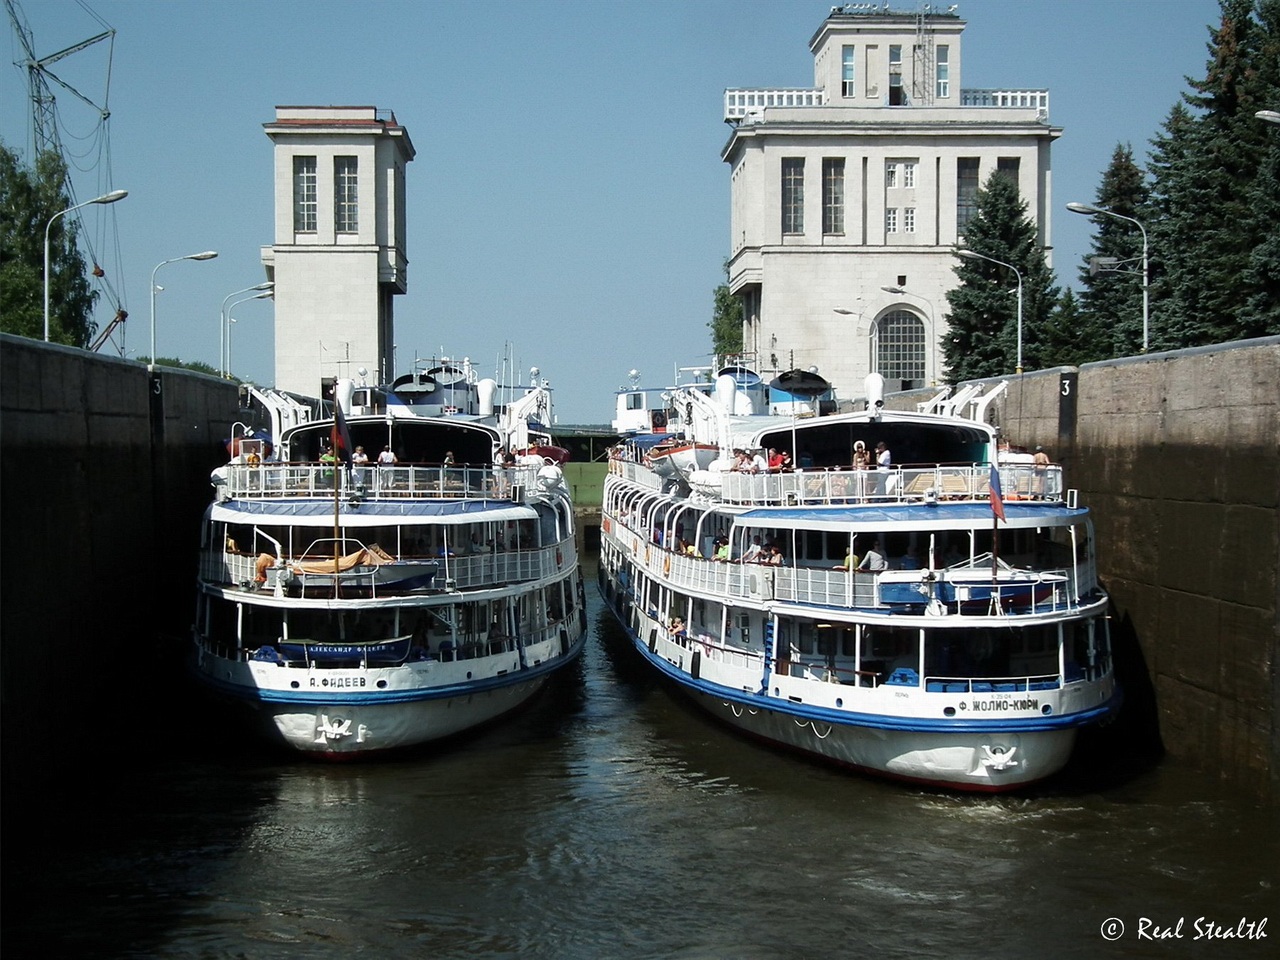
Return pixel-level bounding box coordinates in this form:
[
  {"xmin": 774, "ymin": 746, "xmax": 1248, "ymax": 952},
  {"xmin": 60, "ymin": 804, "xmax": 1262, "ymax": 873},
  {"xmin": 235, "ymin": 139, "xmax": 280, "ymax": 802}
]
[{"xmin": 942, "ymin": 172, "xmax": 1059, "ymax": 383}]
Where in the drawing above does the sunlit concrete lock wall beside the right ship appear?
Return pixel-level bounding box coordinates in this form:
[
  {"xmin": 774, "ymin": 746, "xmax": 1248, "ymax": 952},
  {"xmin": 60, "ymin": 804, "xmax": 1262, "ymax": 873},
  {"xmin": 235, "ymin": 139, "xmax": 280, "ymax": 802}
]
[{"xmin": 888, "ymin": 337, "xmax": 1280, "ymax": 794}]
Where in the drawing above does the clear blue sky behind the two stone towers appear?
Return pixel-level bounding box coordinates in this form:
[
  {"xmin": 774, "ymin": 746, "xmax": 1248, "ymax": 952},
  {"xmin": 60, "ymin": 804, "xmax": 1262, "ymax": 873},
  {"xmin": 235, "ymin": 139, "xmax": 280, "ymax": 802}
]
[{"xmin": 0, "ymin": 0, "xmax": 1219, "ymax": 424}]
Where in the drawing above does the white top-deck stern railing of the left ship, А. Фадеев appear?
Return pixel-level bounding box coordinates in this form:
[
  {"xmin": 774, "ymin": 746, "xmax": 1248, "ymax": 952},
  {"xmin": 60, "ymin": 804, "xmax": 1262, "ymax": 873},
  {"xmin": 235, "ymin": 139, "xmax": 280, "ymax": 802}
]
[{"xmin": 224, "ymin": 461, "xmax": 539, "ymax": 499}]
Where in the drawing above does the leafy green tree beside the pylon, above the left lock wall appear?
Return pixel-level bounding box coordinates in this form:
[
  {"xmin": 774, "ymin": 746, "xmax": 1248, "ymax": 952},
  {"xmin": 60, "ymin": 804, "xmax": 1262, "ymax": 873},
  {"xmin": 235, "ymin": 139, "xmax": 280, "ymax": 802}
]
[{"xmin": 0, "ymin": 142, "xmax": 97, "ymax": 347}]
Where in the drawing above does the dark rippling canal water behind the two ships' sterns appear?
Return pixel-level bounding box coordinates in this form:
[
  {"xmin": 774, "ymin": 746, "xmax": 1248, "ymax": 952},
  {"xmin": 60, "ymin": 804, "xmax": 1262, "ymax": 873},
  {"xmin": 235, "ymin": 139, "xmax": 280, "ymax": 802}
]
[{"xmin": 3, "ymin": 568, "xmax": 1280, "ymax": 960}]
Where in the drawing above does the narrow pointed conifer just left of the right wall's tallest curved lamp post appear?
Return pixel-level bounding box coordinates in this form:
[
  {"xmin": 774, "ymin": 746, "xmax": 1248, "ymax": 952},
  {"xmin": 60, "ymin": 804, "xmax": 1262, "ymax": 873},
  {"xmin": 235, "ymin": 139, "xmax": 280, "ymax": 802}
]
[{"xmin": 1071, "ymin": 143, "xmax": 1149, "ymax": 364}]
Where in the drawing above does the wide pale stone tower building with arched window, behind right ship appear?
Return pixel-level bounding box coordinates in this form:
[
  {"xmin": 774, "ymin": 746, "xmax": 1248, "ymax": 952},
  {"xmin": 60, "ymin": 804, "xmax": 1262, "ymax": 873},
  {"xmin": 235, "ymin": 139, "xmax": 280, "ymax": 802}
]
[{"xmin": 722, "ymin": 4, "xmax": 1061, "ymax": 398}]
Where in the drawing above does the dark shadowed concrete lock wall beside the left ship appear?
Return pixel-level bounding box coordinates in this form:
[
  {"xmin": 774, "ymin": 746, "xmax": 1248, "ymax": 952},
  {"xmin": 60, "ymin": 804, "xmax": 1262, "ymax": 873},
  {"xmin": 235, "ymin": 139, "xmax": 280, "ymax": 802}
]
[{"xmin": 0, "ymin": 335, "xmax": 238, "ymax": 772}]
